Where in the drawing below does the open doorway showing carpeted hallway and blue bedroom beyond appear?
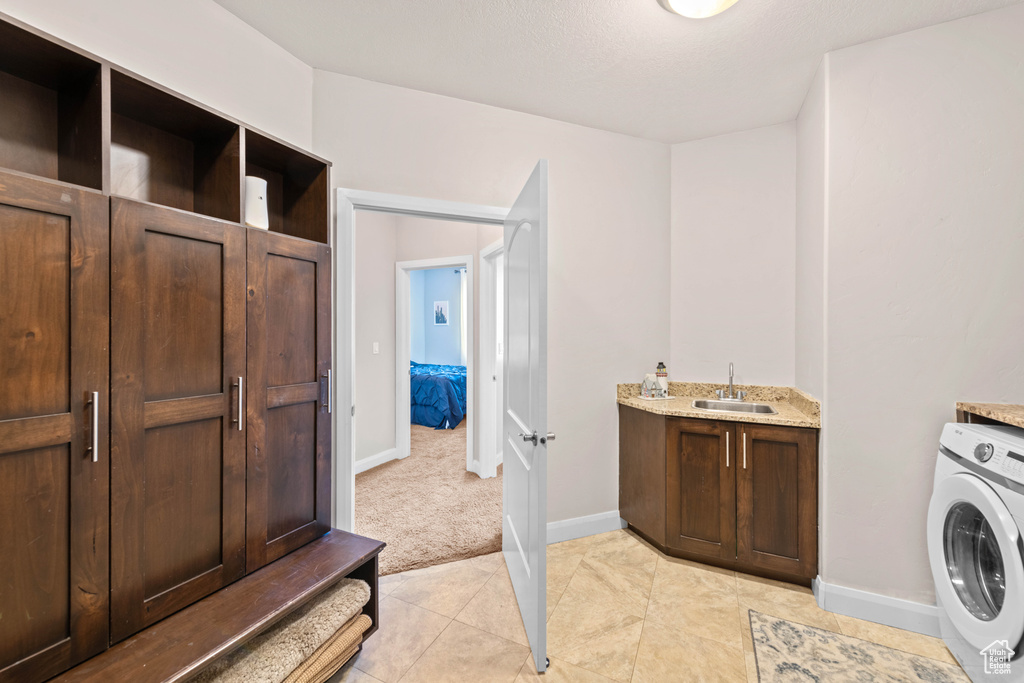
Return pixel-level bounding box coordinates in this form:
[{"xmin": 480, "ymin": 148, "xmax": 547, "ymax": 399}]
[{"xmin": 337, "ymin": 192, "xmax": 503, "ymax": 574}]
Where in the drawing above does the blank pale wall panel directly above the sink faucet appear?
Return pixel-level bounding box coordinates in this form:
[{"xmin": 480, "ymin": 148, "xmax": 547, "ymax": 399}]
[{"xmin": 671, "ymin": 123, "xmax": 796, "ymax": 386}]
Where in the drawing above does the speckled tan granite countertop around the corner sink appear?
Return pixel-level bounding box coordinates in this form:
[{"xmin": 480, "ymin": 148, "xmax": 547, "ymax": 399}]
[{"xmin": 617, "ymin": 382, "xmax": 823, "ymax": 429}]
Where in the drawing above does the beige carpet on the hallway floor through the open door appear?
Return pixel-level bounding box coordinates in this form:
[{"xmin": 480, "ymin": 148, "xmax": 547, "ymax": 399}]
[{"xmin": 355, "ymin": 420, "xmax": 502, "ymax": 575}]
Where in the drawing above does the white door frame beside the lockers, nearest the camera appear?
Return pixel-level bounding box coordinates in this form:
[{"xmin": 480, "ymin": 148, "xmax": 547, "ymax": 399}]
[{"xmin": 331, "ymin": 187, "xmax": 509, "ymax": 531}]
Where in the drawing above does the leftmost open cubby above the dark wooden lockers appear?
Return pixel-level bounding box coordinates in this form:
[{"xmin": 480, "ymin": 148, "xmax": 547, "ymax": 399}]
[{"xmin": 0, "ymin": 23, "xmax": 103, "ymax": 189}]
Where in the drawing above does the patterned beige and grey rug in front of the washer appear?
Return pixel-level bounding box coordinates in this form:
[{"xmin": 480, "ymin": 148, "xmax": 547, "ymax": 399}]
[{"xmin": 750, "ymin": 609, "xmax": 970, "ymax": 683}]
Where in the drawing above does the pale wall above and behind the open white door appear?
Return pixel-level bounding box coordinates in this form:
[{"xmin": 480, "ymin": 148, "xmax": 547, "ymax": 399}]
[{"xmin": 313, "ymin": 71, "xmax": 670, "ymax": 521}]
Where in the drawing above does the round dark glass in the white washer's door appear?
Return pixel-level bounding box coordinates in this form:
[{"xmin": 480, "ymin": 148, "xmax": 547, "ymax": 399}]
[{"xmin": 942, "ymin": 502, "xmax": 1007, "ymax": 622}]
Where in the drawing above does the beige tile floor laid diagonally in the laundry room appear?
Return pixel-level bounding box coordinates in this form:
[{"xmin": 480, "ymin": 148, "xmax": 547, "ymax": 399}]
[{"xmin": 332, "ymin": 530, "xmax": 954, "ymax": 683}]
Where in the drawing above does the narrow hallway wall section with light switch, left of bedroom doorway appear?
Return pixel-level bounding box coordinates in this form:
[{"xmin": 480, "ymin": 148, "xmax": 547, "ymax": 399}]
[{"xmin": 353, "ymin": 211, "xmax": 397, "ymax": 460}]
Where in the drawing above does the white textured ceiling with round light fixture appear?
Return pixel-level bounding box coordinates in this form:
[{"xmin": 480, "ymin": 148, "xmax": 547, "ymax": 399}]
[{"xmin": 216, "ymin": 0, "xmax": 1019, "ymax": 142}]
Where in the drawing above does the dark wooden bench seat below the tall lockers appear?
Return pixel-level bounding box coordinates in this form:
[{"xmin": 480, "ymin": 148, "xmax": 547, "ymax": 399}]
[{"xmin": 54, "ymin": 529, "xmax": 384, "ymax": 683}]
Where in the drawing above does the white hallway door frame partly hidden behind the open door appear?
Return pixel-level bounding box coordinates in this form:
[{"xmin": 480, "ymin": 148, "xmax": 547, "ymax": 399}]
[{"xmin": 476, "ymin": 240, "xmax": 505, "ymax": 477}]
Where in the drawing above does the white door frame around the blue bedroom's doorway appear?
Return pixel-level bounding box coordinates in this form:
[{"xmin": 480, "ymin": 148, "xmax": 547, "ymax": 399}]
[{"xmin": 397, "ymin": 254, "xmax": 480, "ymax": 475}]
